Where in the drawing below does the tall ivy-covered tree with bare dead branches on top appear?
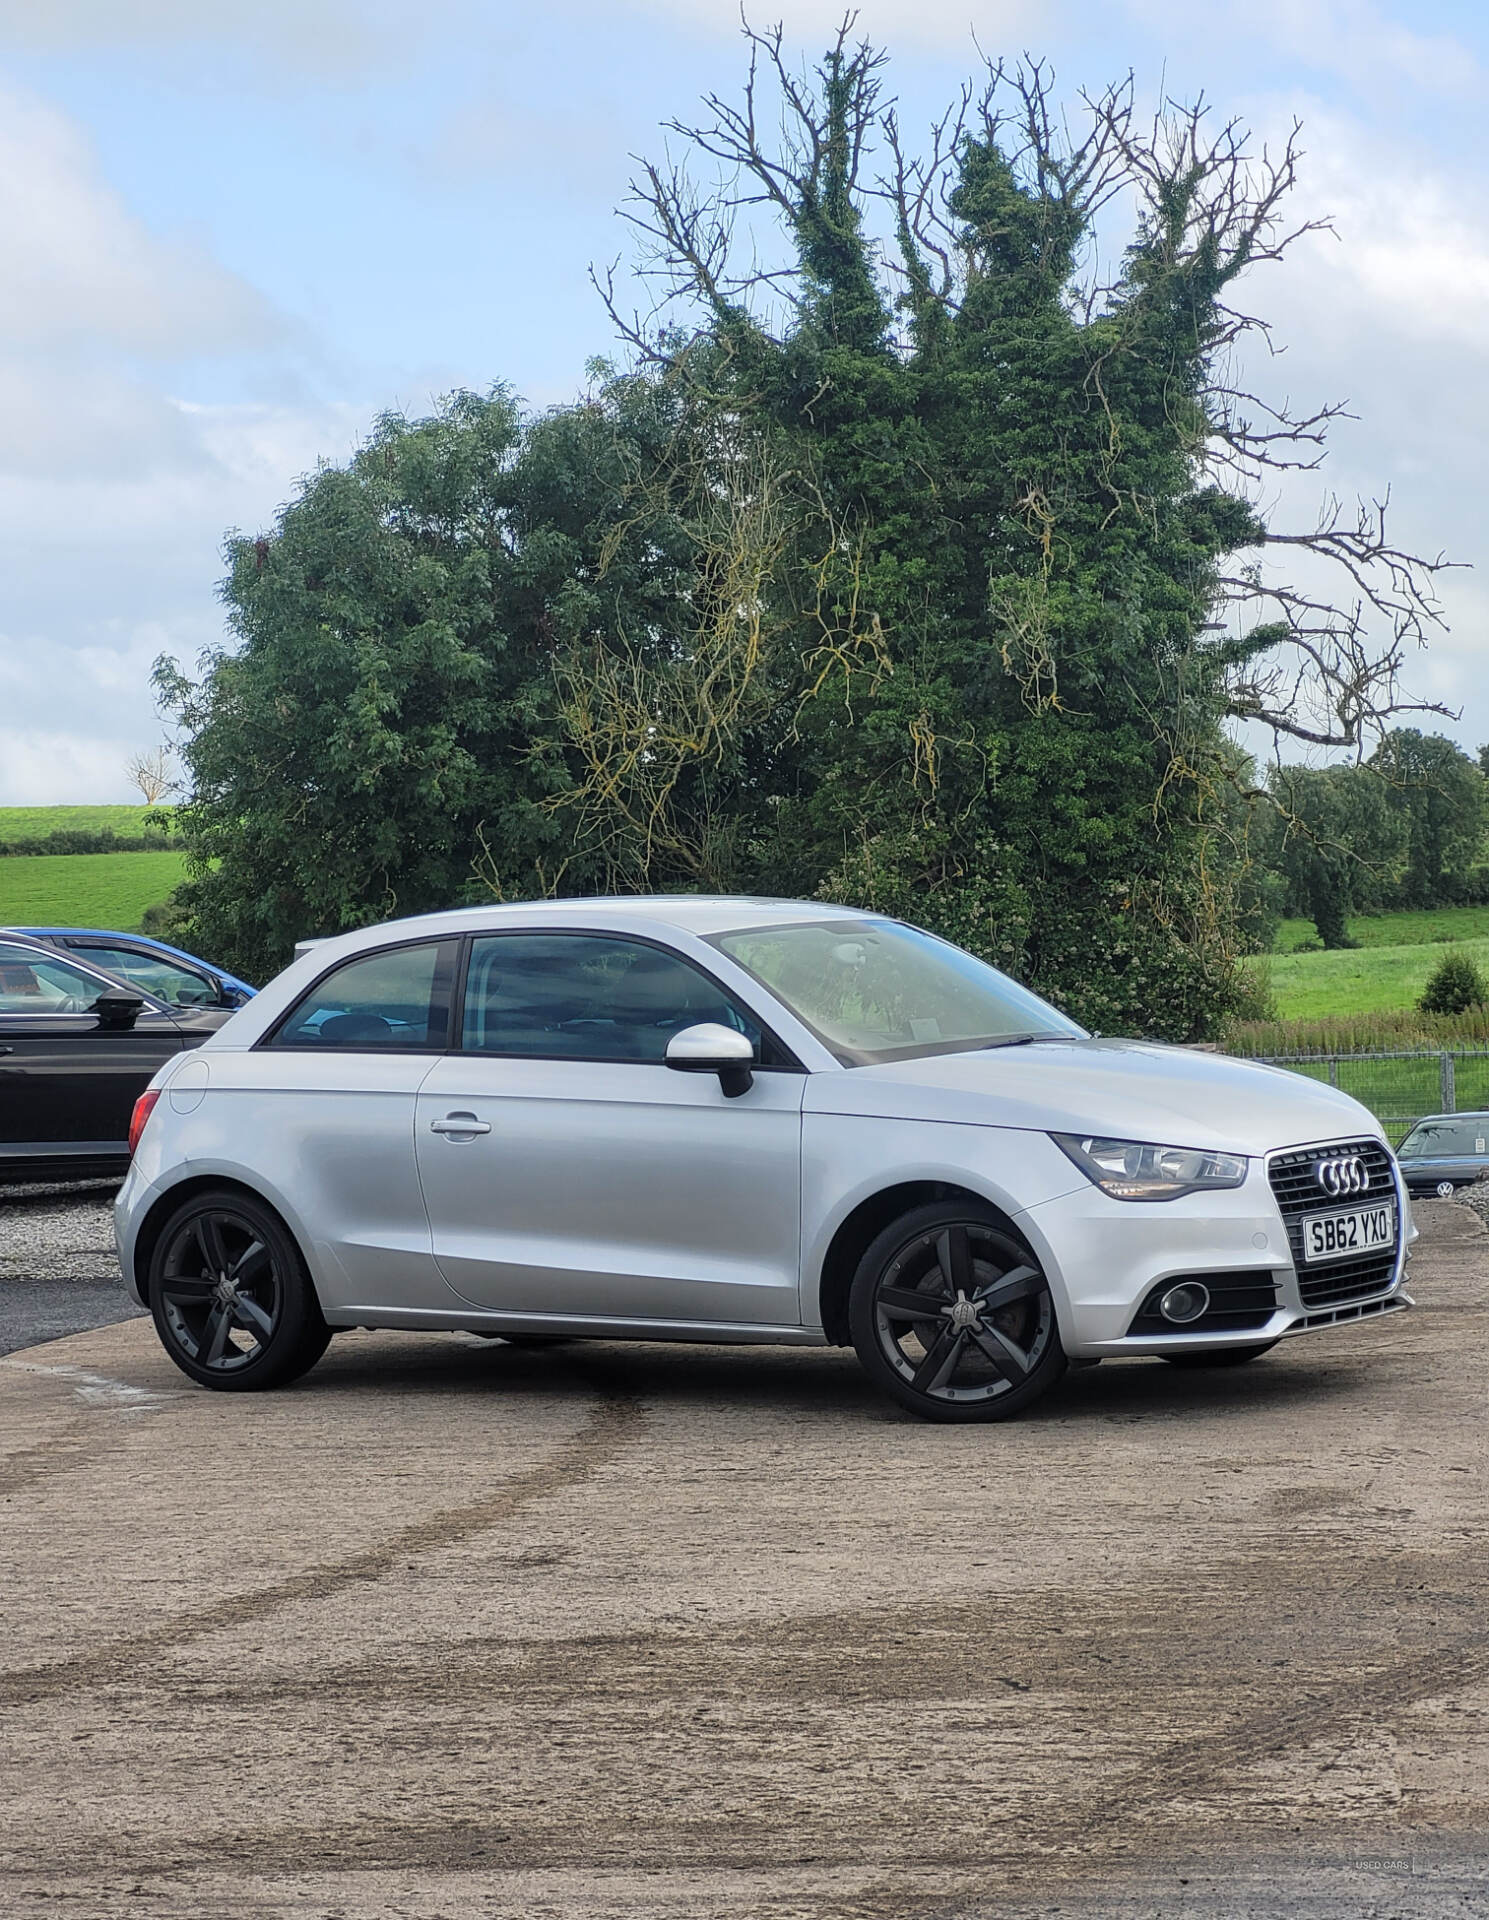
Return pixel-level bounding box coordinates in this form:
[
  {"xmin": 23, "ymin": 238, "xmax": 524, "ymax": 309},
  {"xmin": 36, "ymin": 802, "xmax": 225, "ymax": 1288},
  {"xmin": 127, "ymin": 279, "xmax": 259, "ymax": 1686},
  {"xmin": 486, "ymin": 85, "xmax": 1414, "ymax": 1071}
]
[{"xmin": 587, "ymin": 31, "xmax": 1437, "ymax": 1037}]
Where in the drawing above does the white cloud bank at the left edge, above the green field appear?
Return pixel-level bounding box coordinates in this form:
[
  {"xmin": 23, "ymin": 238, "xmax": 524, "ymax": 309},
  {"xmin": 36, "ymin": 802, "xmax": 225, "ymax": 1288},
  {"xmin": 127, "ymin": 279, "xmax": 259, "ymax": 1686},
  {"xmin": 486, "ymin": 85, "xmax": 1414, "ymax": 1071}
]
[{"xmin": 0, "ymin": 88, "xmax": 353, "ymax": 803}]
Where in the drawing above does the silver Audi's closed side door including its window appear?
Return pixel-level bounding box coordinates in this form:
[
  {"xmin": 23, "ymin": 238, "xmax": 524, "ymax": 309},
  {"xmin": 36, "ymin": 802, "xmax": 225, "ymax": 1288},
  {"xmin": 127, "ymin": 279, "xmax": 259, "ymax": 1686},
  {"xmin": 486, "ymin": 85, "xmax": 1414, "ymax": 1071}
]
[{"xmin": 416, "ymin": 931, "xmax": 804, "ymax": 1327}]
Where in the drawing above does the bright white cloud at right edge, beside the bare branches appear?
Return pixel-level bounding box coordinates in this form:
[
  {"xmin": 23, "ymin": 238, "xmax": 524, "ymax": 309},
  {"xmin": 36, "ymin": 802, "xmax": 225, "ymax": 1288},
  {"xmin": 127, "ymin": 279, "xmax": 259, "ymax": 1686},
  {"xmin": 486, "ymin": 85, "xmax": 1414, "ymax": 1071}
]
[{"xmin": 1220, "ymin": 100, "xmax": 1489, "ymax": 749}]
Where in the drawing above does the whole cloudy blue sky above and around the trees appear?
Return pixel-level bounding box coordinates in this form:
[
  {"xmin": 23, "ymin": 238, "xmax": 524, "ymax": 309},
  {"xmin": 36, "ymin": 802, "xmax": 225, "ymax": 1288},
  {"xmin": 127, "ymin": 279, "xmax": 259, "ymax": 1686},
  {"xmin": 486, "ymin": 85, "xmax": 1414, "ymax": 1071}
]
[{"xmin": 0, "ymin": 0, "xmax": 1489, "ymax": 804}]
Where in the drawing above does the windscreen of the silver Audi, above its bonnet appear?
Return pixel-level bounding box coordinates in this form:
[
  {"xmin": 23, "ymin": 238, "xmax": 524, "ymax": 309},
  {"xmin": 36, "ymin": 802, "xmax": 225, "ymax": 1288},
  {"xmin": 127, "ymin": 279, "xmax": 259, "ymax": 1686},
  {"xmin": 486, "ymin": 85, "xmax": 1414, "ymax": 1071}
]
[{"xmin": 712, "ymin": 918, "xmax": 1086, "ymax": 1066}]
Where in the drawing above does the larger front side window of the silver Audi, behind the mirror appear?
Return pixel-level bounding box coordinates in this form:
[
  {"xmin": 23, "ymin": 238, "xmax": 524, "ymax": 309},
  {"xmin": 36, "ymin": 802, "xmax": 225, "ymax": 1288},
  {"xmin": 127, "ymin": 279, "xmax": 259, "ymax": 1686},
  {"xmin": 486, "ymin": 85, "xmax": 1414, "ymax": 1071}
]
[{"xmin": 461, "ymin": 933, "xmax": 769, "ymax": 1064}]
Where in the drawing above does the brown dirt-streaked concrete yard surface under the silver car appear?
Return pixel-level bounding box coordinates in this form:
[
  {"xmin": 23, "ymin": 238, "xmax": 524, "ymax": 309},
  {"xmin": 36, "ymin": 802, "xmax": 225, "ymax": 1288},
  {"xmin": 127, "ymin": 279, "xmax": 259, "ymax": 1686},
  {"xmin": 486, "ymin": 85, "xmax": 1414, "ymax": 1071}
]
[{"xmin": 0, "ymin": 1204, "xmax": 1489, "ymax": 1920}]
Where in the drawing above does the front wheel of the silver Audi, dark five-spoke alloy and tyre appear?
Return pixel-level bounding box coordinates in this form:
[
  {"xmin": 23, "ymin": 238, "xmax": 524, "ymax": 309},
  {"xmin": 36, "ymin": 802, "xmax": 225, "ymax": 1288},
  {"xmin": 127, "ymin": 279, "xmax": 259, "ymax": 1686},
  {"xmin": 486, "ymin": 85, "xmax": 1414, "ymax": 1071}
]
[{"xmin": 848, "ymin": 1200, "xmax": 1065, "ymax": 1421}]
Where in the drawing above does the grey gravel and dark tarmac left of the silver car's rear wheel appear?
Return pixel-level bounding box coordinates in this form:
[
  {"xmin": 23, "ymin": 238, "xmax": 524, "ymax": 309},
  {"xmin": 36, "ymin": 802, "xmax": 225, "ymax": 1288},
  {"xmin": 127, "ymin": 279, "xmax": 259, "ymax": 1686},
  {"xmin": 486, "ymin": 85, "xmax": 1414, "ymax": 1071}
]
[{"xmin": 0, "ymin": 1183, "xmax": 140, "ymax": 1354}]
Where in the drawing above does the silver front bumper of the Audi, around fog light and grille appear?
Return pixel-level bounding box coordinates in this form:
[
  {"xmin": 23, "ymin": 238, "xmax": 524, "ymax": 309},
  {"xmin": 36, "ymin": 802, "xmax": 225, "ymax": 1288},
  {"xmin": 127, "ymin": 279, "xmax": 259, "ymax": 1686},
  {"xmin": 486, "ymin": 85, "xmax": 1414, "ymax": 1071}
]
[{"xmin": 1017, "ymin": 1160, "xmax": 1416, "ymax": 1359}]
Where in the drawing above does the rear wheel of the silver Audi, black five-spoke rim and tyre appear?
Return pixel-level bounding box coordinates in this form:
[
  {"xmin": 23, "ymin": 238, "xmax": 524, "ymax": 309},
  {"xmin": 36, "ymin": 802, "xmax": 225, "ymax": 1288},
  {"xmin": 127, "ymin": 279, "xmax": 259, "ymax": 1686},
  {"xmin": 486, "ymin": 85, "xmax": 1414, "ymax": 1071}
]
[{"xmin": 148, "ymin": 1188, "xmax": 330, "ymax": 1392}]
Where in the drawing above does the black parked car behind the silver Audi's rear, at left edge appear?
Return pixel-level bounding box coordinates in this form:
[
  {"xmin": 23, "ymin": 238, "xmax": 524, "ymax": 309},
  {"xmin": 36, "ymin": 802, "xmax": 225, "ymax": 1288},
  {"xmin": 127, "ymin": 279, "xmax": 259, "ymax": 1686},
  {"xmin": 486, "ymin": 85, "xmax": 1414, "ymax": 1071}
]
[{"xmin": 0, "ymin": 933, "xmax": 232, "ymax": 1181}]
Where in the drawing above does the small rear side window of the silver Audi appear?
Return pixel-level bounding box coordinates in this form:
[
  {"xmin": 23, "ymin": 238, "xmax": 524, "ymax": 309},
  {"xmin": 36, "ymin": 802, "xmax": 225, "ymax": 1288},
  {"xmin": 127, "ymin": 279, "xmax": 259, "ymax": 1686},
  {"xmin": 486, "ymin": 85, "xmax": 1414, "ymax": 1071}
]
[{"xmin": 269, "ymin": 941, "xmax": 455, "ymax": 1054}]
